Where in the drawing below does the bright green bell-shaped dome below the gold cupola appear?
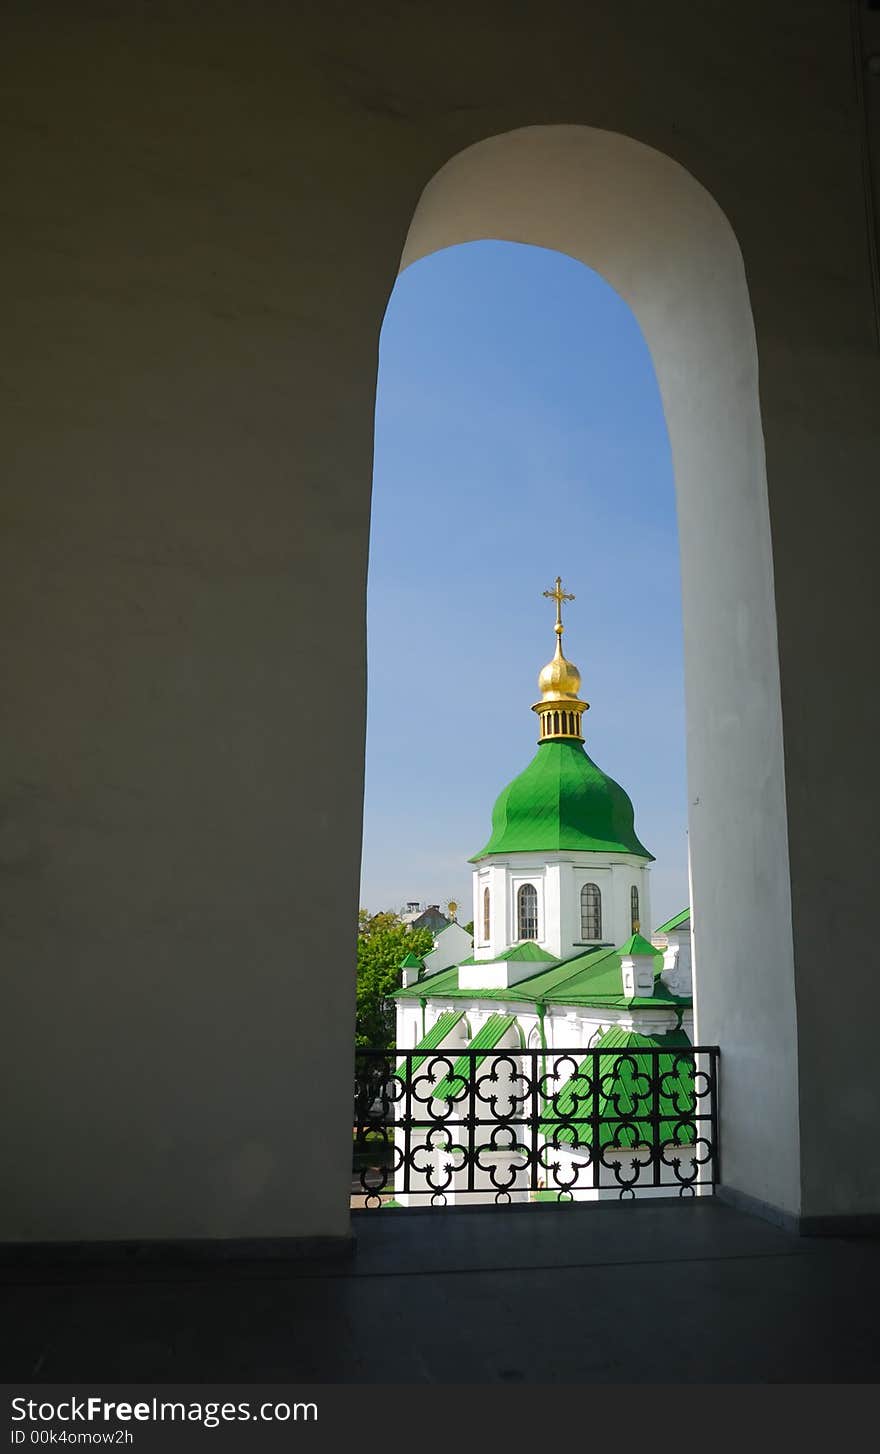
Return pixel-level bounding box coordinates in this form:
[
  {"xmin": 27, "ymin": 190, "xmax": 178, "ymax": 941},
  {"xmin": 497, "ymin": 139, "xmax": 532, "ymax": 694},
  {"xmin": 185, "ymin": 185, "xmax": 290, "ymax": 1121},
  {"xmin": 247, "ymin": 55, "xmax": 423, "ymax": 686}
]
[{"xmin": 470, "ymin": 742, "xmax": 653, "ymax": 864}]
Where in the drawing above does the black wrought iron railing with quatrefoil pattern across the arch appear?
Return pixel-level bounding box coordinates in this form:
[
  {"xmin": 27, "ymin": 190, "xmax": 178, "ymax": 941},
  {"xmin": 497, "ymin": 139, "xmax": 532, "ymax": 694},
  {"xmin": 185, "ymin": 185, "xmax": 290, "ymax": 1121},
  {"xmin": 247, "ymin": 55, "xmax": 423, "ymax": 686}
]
[{"xmin": 352, "ymin": 1045, "xmax": 719, "ymax": 1207}]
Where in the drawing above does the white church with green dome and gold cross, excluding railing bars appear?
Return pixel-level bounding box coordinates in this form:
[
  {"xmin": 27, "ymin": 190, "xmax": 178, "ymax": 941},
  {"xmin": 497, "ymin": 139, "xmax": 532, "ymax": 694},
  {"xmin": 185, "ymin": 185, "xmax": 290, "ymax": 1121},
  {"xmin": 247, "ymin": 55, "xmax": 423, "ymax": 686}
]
[{"xmin": 394, "ymin": 577, "xmax": 692, "ymax": 1204}]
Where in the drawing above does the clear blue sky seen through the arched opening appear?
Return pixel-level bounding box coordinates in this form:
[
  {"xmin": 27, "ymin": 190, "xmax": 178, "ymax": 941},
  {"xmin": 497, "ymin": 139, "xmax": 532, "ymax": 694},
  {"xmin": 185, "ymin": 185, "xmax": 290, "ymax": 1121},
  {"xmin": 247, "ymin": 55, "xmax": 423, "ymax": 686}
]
[{"xmin": 361, "ymin": 243, "xmax": 688, "ymax": 923}]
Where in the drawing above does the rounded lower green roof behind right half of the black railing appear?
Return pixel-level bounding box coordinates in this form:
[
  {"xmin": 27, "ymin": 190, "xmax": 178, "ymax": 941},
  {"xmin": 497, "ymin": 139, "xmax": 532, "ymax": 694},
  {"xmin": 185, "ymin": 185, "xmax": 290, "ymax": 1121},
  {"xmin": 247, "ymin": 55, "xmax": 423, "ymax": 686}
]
[{"xmin": 541, "ymin": 1025, "xmax": 697, "ymax": 1149}]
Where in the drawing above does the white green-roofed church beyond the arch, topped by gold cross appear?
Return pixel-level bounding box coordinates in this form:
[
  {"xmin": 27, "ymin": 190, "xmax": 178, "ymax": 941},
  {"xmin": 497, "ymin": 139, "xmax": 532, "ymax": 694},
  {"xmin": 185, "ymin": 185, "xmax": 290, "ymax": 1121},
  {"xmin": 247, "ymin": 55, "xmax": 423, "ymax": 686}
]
[{"xmin": 394, "ymin": 579, "xmax": 708, "ymax": 1205}]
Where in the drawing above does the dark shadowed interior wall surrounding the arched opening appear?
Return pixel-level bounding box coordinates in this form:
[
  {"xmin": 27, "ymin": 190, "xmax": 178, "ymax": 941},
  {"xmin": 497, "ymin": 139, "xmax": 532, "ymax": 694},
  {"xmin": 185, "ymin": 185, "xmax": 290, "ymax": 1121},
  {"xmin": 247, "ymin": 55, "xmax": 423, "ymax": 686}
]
[{"xmin": 0, "ymin": 0, "xmax": 880, "ymax": 1239}]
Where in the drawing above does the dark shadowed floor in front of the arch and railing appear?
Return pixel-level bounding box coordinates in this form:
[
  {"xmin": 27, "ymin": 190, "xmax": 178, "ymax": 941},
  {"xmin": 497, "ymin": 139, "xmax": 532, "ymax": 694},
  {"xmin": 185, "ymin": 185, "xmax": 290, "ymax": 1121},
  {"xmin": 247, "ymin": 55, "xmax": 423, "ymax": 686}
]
[{"xmin": 1, "ymin": 1200, "xmax": 880, "ymax": 1384}]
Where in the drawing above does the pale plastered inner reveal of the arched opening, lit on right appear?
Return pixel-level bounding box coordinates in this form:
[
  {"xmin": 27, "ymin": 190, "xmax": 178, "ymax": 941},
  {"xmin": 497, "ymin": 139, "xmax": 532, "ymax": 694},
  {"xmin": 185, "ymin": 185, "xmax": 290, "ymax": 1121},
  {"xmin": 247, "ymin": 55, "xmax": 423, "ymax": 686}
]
[{"xmin": 403, "ymin": 125, "xmax": 800, "ymax": 1213}]
